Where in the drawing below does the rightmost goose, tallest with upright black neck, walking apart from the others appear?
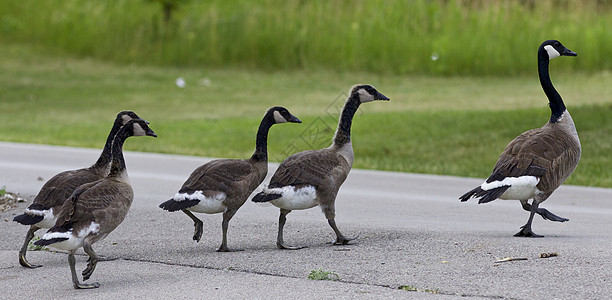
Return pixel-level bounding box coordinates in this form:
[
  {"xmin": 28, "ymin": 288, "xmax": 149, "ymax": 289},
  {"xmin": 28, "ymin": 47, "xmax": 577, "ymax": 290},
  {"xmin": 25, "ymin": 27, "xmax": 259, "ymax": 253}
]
[{"xmin": 459, "ymin": 40, "xmax": 581, "ymax": 237}]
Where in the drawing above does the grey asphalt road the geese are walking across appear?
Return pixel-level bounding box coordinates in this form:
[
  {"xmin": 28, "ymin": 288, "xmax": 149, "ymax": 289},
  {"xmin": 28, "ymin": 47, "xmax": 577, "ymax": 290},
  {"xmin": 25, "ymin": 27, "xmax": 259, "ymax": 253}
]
[{"xmin": 0, "ymin": 140, "xmax": 612, "ymax": 299}]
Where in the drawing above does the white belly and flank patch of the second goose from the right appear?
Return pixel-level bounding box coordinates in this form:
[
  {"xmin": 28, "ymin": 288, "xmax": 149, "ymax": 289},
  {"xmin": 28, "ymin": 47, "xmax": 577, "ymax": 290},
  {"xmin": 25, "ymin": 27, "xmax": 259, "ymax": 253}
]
[{"xmin": 264, "ymin": 185, "xmax": 319, "ymax": 210}]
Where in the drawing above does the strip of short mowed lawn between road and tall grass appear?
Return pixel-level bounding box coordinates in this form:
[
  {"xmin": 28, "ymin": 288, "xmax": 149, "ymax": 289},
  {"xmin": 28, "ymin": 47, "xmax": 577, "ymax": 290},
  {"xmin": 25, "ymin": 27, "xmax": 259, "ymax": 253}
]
[{"xmin": 0, "ymin": 44, "xmax": 612, "ymax": 187}]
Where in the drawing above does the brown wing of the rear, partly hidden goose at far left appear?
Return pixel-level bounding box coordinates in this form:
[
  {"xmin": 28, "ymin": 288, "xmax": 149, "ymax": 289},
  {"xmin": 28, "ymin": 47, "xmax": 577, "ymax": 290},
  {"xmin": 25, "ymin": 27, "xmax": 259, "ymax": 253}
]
[{"xmin": 32, "ymin": 168, "xmax": 101, "ymax": 209}]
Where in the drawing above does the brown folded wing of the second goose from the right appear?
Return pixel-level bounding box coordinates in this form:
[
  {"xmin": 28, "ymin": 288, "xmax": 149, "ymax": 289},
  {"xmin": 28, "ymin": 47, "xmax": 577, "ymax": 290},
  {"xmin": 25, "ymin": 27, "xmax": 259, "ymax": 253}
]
[{"xmin": 268, "ymin": 149, "xmax": 350, "ymax": 190}]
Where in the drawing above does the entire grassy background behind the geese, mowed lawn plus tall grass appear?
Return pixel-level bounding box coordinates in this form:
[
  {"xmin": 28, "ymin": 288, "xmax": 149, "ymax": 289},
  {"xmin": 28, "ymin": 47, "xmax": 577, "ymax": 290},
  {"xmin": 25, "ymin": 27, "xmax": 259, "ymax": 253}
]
[{"xmin": 0, "ymin": 0, "xmax": 612, "ymax": 187}]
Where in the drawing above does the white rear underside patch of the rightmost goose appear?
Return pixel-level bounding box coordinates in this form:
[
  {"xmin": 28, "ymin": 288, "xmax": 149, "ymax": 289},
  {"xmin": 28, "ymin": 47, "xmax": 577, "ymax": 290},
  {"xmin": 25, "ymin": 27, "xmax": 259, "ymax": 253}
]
[{"xmin": 480, "ymin": 176, "xmax": 540, "ymax": 200}]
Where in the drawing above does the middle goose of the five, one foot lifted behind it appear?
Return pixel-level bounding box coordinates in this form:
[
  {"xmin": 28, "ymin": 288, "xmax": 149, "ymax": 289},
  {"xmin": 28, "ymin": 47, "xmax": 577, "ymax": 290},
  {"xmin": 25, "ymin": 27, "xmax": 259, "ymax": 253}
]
[{"xmin": 159, "ymin": 106, "xmax": 302, "ymax": 252}]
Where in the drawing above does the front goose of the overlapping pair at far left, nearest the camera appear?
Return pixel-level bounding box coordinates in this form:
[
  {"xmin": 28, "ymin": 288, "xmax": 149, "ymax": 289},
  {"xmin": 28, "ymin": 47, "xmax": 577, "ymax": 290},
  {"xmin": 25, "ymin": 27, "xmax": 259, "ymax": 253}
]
[{"xmin": 34, "ymin": 119, "xmax": 157, "ymax": 289}]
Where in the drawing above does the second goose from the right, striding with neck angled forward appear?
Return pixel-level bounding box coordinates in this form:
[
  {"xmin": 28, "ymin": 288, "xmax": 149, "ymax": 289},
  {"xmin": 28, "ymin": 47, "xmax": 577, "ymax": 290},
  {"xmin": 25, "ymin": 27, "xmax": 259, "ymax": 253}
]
[{"xmin": 252, "ymin": 85, "xmax": 389, "ymax": 250}]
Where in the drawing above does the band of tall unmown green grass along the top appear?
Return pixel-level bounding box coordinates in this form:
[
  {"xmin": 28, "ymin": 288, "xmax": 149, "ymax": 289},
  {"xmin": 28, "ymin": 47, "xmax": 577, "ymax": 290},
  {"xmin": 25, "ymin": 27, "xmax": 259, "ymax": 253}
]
[{"xmin": 0, "ymin": 0, "xmax": 612, "ymax": 75}]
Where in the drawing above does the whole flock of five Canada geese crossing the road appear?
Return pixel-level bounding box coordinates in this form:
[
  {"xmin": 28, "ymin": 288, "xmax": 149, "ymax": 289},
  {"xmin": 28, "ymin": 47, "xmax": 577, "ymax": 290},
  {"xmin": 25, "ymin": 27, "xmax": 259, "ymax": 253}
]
[{"xmin": 14, "ymin": 40, "xmax": 581, "ymax": 288}]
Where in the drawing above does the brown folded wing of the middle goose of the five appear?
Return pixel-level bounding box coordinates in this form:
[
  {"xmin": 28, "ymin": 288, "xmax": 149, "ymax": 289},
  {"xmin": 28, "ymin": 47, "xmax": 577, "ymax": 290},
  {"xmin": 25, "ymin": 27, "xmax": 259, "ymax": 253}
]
[{"xmin": 179, "ymin": 159, "xmax": 263, "ymax": 197}]
